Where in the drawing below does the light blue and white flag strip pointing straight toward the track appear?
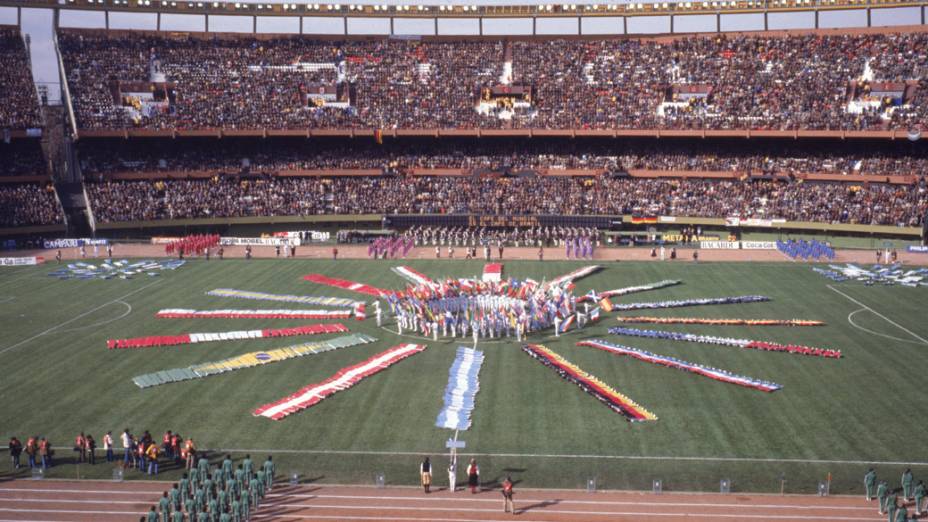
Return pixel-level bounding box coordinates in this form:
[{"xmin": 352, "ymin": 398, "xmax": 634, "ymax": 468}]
[{"xmin": 435, "ymin": 346, "xmax": 484, "ymax": 430}]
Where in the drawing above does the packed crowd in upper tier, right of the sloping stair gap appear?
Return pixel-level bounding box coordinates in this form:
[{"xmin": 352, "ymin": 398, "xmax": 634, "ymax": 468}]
[{"xmin": 59, "ymin": 31, "xmax": 928, "ymax": 130}]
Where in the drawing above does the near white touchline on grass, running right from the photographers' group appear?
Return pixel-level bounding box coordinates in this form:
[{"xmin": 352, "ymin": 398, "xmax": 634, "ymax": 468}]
[{"xmin": 207, "ymin": 448, "xmax": 928, "ymax": 466}]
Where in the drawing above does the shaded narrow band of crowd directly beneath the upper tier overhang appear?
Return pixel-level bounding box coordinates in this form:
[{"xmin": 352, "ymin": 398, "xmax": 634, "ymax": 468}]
[{"xmin": 80, "ymin": 138, "xmax": 928, "ymax": 180}]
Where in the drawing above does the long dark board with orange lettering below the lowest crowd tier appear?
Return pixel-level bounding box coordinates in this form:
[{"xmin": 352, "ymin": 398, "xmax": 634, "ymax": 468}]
[{"xmin": 387, "ymin": 214, "xmax": 622, "ymax": 229}]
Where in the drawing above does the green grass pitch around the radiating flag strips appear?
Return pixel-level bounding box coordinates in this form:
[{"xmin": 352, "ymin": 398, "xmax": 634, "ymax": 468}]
[{"xmin": 0, "ymin": 260, "xmax": 928, "ymax": 493}]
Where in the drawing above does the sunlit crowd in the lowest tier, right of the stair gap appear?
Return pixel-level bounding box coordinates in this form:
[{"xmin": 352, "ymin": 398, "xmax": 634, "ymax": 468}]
[{"xmin": 87, "ymin": 176, "xmax": 928, "ymax": 226}]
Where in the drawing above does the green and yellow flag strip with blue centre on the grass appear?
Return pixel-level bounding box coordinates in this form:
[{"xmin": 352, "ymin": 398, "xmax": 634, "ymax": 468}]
[{"xmin": 132, "ymin": 334, "xmax": 377, "ymax": 388}]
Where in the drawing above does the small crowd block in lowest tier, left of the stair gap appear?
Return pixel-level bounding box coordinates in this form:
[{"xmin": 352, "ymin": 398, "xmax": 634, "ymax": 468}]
[{"xmin": 0, "ymin": 183, "xmax": 64, "ymax": 228}]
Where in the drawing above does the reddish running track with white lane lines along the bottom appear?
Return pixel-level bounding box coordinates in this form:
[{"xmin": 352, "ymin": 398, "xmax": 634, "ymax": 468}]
[{"xmin": 0, "ymin": 480, "xmax": 885, "ymax": 522}]
